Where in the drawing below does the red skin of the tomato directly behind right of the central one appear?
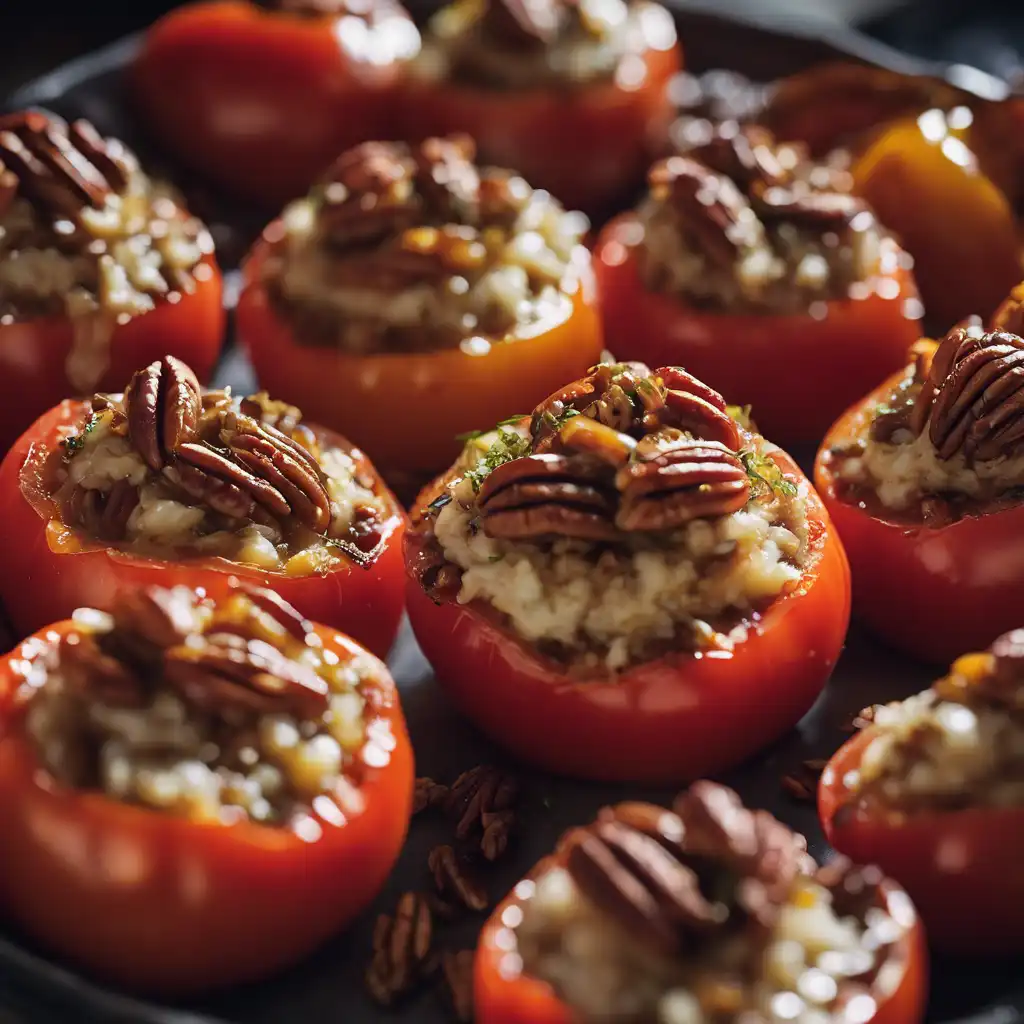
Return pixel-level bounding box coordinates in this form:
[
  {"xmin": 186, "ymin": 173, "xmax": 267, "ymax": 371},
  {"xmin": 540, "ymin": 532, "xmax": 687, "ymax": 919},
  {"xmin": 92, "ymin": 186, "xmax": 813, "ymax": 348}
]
[{"xmin": 595, "ymin": 215, "xmax": 920, "ymax": 444}]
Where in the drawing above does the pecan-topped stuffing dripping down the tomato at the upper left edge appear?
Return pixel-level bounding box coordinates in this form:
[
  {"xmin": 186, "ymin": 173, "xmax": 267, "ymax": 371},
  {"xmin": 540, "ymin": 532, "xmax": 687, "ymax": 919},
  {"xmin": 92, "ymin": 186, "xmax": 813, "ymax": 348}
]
[{"xmin": 0, "ymin": 112, "xmax": 213, "ymax": 391}]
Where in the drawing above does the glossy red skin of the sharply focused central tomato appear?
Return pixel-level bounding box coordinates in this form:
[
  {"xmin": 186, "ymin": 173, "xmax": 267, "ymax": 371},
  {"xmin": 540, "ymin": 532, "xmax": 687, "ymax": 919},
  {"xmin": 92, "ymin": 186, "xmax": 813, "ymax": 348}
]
[{"xmin": 406, "ymin": 453, "xmax": 850, "ymax": 783}]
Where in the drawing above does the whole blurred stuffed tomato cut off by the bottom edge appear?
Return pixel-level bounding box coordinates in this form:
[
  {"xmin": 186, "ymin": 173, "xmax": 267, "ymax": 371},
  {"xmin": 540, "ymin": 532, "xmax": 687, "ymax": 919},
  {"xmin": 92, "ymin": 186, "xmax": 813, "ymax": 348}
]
[{"xmin": 475, "ymin": 781, "xmax": 926, "ymax": 1024}]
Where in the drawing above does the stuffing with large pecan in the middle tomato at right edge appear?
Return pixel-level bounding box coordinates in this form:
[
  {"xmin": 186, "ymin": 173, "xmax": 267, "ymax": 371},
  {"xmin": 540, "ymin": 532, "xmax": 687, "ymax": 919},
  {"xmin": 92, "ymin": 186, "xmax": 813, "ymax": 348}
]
[{"xmin": 829, "ymin": 325, "xmax": 1024, "ymax": 523}]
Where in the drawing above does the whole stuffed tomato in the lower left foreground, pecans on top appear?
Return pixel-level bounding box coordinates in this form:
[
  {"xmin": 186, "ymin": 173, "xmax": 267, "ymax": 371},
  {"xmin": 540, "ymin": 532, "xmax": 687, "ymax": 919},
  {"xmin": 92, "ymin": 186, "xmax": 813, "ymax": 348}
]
[{"xmin": 0, "ymin": 588, "xmax": 413, "ymax": 994}]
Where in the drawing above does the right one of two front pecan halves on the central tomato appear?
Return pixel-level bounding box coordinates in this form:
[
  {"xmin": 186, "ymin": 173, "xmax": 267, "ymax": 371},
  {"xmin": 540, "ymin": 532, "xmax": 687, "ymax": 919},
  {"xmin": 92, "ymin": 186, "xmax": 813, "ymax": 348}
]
[{"xmin": 615, "ymin": 438, "xmax": 751, "ymax": 530}]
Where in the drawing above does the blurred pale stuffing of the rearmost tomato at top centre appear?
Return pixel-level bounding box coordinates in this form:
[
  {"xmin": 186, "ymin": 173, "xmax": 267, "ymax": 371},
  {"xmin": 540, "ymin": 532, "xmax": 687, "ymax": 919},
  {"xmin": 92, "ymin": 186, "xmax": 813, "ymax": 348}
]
[{"xmin": 413, "ymin": 0, "xmax": 676, "ymax": 89}]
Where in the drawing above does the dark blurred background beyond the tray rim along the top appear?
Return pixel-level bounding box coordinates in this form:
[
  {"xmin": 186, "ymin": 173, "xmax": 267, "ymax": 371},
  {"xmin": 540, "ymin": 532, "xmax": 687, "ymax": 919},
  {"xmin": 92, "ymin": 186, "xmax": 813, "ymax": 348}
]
[{"xmin": 6, "ymin": 0, "xmax": 1024, "ymax": 97}]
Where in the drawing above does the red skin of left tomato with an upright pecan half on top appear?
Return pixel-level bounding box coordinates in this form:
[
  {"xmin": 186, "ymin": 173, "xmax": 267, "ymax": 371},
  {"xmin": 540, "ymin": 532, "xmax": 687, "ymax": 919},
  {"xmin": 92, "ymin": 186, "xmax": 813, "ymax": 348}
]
[{"xmin": 0, "ymin": 401, "xmax": 406, "ymax": 657}]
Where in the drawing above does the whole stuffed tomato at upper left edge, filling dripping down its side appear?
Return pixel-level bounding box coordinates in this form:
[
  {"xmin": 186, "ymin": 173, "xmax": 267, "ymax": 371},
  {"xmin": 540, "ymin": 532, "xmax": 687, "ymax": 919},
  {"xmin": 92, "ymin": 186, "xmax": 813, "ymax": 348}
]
[{"xmin": 0, "ymin": 112, "xmax": 223, "ymax": 447}]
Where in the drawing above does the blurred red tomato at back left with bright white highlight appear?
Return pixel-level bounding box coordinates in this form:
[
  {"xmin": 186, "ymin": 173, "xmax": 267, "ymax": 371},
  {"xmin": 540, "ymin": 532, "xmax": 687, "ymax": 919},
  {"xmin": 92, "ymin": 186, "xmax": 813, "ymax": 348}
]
[{"xmin": 134, "ymin": 0, "xmax": 419, "ymax": 208}]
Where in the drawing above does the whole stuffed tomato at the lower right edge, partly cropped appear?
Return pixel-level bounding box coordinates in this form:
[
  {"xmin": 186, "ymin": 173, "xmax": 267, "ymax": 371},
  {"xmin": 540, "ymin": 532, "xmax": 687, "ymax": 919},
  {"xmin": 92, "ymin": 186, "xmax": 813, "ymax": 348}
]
[{"xmin": 819, "ymin": 630, "xmax": 1024, "ymax": 955}]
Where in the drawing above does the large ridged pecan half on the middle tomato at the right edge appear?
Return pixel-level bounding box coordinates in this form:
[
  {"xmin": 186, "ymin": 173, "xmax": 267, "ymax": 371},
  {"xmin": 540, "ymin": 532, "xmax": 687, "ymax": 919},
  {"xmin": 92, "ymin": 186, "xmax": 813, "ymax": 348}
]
[{"xmin": 912, "ymin": 327, "xmax": 1024, "ymax": 461}]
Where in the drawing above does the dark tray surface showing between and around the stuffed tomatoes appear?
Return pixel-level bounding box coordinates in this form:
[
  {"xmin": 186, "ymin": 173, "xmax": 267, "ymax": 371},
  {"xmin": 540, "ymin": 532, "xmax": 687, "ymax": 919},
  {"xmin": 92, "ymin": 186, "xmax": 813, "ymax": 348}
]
[{"xmin": 0, "ymin": 4, "xmax": 1024, "ymax": 1024}]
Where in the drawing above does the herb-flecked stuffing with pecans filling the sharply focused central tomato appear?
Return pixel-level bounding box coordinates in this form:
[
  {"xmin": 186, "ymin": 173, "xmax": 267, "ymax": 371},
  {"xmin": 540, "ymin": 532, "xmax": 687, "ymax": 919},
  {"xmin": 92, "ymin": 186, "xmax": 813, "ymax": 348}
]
[{"xmin": 420, "ymin": 364, "xmax": 808, "ymax": 672}]
